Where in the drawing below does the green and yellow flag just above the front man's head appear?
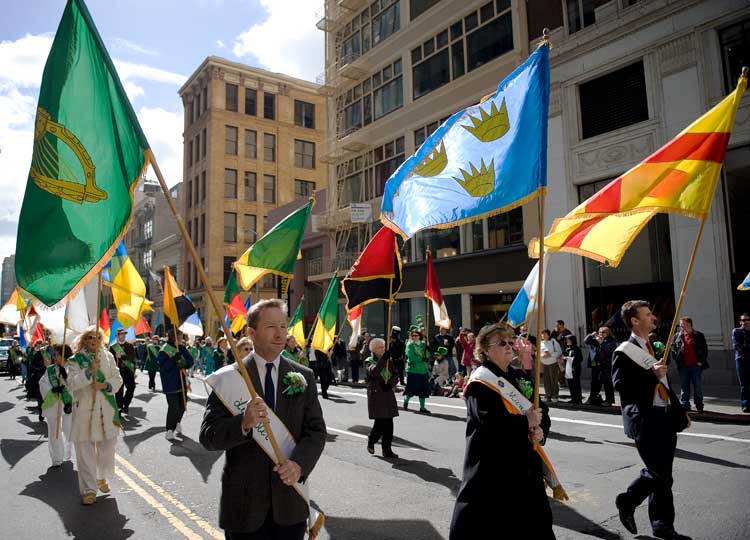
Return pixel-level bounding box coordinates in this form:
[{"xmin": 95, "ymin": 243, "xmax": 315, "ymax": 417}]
[{"xmin": 234, "ymin": 198, "xmax": 315, "ymax": 294}]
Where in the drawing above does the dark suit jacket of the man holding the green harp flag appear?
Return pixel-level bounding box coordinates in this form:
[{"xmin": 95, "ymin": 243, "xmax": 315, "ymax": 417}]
[{"xmin": 200, "ymin": 354, "xmax": 326, "ymax": 532}]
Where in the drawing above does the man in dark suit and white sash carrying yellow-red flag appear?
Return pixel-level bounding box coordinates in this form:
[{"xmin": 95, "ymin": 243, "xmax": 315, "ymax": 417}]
[{"xmin": 612, "ymin": 300, "xmax": 690, "ymax": 540}]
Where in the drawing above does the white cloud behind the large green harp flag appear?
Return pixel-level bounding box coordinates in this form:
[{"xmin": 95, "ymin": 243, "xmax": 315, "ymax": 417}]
[{"xmin": 0, "ymin": 34, "xmax": 186, "ymax": 266}]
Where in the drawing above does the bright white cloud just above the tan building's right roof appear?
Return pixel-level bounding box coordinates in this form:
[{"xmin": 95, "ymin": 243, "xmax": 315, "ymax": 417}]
[{"xmin": 232, "ymin": 0, "xmax": 324, "ymax": 81}]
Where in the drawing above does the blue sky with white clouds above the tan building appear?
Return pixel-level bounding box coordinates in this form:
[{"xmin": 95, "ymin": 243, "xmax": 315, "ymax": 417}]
[{"xmin": 0, "ymin": 0, "xmax": 324, "ymax": 270}]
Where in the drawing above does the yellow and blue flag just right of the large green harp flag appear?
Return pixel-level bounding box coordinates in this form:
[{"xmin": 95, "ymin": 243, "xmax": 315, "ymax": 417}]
[{"xmin": 102, "ymin": 241, "xmax": 151, "ymax": 328}]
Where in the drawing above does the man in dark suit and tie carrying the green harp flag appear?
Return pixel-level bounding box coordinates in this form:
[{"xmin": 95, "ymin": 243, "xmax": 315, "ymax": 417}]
[{"xmin": 200, "ymin": 300, "xmax": 326, "ymax": 540}]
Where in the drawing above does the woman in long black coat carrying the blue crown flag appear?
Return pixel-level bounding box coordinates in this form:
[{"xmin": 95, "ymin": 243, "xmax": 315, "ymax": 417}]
[{"xmin": 450, "ymin": 325, "xmax": 555, "ymax": 540}]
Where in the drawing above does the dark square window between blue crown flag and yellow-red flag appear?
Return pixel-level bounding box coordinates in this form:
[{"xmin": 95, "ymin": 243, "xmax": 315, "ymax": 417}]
[{"xmin": 578, "ymin": 61, "xmax": 648, "ymax": 139}]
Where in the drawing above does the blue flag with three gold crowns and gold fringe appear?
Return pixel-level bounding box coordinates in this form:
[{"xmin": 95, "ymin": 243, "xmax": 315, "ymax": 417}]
[{"xmin": 381, "ymin": 43, "xmax": 549, "ymax": 238}]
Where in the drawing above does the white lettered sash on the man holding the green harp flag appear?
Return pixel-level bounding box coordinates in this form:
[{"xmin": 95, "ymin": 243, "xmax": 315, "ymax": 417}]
[{"xmin": 206, "ymin": 364, "xmax": 324, "ymax": 539}]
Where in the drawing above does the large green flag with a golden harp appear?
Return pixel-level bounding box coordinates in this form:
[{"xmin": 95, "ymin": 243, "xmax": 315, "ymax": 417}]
[{"xmin": 16, "ymin": 0, "xmax": 150, "ymax": 306}]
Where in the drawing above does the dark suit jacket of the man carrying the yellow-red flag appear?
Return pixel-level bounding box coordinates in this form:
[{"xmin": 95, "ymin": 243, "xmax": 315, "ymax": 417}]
[{"xmin": 612, "ymin": 336, "xmax": 684, "ymax": 439}]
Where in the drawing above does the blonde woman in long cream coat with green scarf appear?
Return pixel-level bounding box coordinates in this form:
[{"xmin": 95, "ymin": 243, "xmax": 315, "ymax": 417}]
[{"xmin": 67, "ymin": 326, "xmax": 122, "ymax": 505}]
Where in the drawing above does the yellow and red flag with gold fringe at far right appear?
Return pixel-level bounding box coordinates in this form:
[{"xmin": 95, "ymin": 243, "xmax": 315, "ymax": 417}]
[{"xmin": 529, "ymin": 71, "xmax": 747, "ymax": 266}]
